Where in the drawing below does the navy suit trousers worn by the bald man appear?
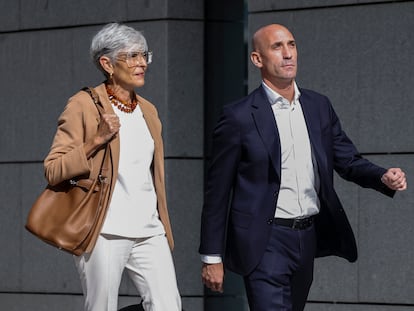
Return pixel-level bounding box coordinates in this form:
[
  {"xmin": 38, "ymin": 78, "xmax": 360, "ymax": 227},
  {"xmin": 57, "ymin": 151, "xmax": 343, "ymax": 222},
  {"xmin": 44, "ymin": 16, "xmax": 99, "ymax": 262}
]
[{"xmin": 244, "ymin": 224, "xmax": 316, "ymax": 311}]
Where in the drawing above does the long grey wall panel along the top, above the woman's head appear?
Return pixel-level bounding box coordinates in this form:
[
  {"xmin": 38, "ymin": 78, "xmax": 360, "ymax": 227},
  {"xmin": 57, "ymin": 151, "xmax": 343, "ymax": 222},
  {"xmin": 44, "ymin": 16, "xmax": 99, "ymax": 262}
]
[{"xmin": 0, "ymin": 0, "xmax": 204, "ymax": 31}]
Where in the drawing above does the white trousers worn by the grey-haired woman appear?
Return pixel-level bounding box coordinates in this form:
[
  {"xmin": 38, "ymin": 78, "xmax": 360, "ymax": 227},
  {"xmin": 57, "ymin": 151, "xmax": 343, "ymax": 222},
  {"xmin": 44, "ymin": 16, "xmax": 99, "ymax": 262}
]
[{"xmin": 74, "ymin": 235, "xmax": 181, "ymax": 311}]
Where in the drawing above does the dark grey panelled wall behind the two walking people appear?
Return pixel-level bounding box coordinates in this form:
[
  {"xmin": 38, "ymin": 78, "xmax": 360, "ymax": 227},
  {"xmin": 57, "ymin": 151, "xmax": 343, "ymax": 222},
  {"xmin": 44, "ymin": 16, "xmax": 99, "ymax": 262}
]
[{"xmin": 0, "ymin": 0, "xmax": 414, "ymax": 311}]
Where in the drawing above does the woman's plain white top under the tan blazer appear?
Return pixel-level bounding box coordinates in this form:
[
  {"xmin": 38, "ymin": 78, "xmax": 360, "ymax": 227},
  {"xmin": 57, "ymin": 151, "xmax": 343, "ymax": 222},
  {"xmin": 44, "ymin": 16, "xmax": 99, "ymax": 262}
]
[{"xmin": 102, "ymin": 106, "xmax": 165, "ymax": 238}]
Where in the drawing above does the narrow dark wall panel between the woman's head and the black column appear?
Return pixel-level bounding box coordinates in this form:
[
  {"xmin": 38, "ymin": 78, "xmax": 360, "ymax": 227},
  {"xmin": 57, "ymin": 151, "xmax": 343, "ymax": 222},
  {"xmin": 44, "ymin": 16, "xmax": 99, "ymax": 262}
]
[{"xmin": 164, "ymin": 22, "xmax": 204, "ymax": 157}]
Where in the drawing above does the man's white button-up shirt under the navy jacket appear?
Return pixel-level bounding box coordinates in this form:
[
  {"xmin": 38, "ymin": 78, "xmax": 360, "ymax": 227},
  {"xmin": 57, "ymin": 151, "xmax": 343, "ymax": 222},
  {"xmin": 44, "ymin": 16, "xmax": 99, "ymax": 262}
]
[{"xmin": 262, "ymin": 82, "xmax": 319, "ymax": 218}]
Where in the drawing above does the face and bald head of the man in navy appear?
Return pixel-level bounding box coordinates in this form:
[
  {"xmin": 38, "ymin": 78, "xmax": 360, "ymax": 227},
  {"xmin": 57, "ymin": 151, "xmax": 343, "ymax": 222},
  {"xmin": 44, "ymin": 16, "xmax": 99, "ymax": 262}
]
[{"xmin": 252, "ymin": 25, "xmax": 297, "ymax": 82}]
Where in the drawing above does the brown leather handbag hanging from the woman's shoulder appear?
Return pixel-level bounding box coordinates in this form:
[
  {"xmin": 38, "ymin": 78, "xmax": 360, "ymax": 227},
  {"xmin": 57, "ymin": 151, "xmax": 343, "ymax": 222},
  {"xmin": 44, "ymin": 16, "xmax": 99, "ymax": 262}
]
[{"xmin": 26, "ymin": 88, "xmax": 110, "ymax": 256}]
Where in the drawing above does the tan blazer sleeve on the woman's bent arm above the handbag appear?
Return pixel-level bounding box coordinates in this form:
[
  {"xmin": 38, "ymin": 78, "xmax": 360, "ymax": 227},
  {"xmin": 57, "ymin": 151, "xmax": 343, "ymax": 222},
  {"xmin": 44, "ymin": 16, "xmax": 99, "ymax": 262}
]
[{"xmin": 44, "ymin": 92, "xmax": 99, "ymax": 185}]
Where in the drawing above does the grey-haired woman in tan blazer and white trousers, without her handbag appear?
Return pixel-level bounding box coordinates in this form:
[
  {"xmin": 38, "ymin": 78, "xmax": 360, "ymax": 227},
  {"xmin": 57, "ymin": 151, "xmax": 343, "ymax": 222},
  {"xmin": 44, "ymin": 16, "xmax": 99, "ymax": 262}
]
[{"xmin": 44, "ymin": 23, "xmax": 181, "ymax": 311}]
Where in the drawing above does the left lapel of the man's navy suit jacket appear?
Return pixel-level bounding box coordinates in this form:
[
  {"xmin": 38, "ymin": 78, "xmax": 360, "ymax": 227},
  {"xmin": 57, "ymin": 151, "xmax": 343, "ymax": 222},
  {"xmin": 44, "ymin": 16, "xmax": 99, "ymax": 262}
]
[{"xmin": 251, "ymin": 87, "xmax": 281, "ymax": 180}]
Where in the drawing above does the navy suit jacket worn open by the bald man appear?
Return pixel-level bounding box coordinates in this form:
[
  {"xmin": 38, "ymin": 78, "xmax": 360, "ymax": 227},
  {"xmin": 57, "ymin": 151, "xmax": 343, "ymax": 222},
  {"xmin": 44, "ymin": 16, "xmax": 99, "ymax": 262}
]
[{"xmin": 199, "ymin": 86, "xmax": 395, "ymax": 275}]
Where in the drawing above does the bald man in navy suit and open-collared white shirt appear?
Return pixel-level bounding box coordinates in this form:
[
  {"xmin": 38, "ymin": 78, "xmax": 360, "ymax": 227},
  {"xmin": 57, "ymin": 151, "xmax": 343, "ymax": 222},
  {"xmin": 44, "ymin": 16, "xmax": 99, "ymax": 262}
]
[{"xmin": 199, "ymin": 24, "xmax": 407, "ymax": 311}]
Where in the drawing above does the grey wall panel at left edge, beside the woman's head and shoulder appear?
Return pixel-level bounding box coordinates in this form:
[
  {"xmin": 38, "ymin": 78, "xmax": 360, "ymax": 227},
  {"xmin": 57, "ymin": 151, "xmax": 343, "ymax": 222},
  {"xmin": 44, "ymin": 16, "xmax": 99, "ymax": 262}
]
[{"xmin": 0, "ymin": 31, "xmax": 78, "ymax": 161}]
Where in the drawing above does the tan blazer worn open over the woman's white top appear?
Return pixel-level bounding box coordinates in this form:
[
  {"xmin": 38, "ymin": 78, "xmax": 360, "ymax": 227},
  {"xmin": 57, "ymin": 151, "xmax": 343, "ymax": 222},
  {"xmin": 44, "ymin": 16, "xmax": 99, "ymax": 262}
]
[{"xmin": 44, "ymin": 84, "xmax": 174, "ymax": 252}]
